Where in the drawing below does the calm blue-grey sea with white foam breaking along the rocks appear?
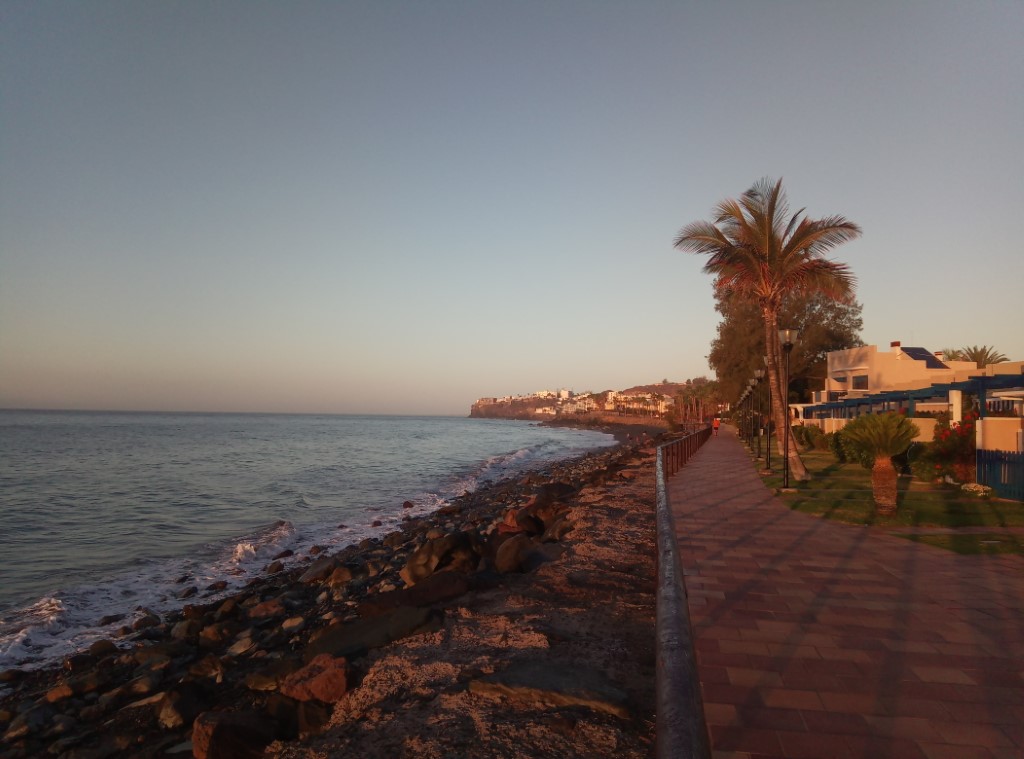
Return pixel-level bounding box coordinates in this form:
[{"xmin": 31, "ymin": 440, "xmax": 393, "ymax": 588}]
[{"xmin": 0, "ymin": 411, "xmax": 614, "ymax": 670}]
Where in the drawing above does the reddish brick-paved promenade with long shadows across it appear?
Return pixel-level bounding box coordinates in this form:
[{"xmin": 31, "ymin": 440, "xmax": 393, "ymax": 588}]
[{"xmin": 669, "ymin": 427, "xmax": 1024, "ymax": 759}]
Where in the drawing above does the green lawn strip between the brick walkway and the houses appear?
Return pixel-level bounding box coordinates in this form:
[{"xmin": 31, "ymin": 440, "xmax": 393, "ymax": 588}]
[{"xmin": 757, "ymin": 451, "xmax": 1024, "ymax": 554}]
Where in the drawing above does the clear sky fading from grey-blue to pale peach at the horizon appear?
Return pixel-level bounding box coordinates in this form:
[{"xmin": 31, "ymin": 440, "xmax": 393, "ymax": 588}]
[{"xmin": 0, "ymin": 0, "xmax": 1024, "ymax": 415}]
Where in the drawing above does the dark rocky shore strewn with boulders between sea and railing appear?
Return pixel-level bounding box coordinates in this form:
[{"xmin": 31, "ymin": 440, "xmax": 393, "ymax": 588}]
[{"xmin": 0, "ymin": 429, "xmax": 656, "ymax": 759}]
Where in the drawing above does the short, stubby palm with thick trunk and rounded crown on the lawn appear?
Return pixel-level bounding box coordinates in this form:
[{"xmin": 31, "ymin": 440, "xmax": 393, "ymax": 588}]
[{"xmin": 842, "ymin": 412, "xmax": 918, "ymax": 515}]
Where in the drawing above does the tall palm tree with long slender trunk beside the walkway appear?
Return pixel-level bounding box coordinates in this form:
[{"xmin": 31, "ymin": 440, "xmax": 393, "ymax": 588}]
[{"xmin": 674, "ymin": 178, "xmax": 860, "ymax": 479}]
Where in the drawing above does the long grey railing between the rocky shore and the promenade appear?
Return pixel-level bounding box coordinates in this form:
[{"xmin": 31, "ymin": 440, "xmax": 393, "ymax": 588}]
[{"xmin": 654, "ymin": 428, "xmax": 711, "ymax": 759}]
